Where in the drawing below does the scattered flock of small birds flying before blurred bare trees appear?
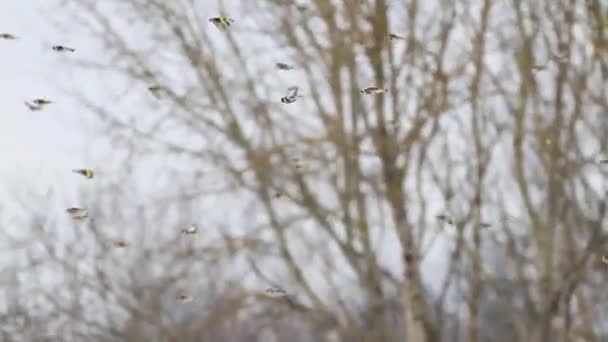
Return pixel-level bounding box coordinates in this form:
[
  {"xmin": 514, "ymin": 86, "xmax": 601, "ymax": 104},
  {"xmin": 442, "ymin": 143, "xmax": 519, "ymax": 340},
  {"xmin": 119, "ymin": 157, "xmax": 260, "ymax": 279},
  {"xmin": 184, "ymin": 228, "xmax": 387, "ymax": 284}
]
[{"xmin": 5, "ymin": 12, "xmax": 608, "ymax": 303}]
